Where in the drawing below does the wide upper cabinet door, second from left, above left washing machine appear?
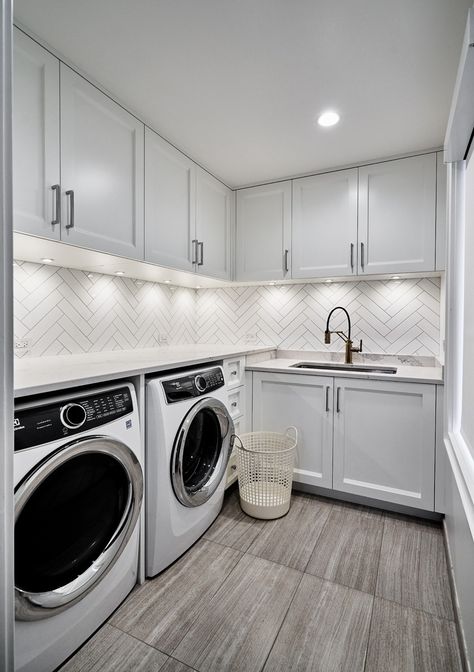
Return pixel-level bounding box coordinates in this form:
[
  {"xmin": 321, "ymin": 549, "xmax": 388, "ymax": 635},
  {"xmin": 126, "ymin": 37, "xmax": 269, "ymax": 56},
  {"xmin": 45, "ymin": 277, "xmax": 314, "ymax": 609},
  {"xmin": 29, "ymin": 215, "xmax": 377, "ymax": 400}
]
[{"xmin": 61, "ymin": 63, "xmax": 144, "ymax": 259}]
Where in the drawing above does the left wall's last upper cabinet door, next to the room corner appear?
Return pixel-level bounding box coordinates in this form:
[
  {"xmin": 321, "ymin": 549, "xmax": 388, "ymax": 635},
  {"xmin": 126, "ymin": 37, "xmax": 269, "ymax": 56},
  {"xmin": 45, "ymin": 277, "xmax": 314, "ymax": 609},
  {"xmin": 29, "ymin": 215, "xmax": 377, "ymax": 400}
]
[{"xmin": 196, "ymin": 168, "xmax": 233, "ymax": 280}]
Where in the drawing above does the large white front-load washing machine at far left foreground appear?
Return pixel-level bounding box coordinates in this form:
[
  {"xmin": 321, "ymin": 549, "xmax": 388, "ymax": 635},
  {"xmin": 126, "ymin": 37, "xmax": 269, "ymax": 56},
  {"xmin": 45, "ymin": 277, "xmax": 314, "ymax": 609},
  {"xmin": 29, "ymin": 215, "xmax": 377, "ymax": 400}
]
[{"xmin": 14, "ymin": 383, "xmax": 143, "ymax": 672}]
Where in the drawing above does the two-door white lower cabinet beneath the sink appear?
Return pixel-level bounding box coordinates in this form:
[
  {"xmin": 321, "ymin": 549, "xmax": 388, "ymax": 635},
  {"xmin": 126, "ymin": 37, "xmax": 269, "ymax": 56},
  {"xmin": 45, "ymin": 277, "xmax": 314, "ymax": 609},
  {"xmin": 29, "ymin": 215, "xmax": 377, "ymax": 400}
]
[{"xmin": 253, "ymin": 372, "xmax": 436, "ymax": 511}]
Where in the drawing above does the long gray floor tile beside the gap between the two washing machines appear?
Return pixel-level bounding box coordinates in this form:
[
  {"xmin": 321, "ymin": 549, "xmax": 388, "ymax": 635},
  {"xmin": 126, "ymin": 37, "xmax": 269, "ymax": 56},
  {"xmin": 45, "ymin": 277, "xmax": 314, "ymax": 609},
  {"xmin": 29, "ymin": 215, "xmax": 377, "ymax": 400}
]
[{"xmin": 110, "ymin": 540, "xmax": 242, "ymax": 653}]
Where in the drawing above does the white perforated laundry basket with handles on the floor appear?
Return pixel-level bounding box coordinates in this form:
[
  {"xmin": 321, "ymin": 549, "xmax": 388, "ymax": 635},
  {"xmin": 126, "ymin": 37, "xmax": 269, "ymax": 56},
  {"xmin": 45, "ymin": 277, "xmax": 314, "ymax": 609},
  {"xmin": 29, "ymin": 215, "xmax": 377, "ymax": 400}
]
[{"xmin": 234, "ymin": 427, "xmax": 298, "ymax": 520}]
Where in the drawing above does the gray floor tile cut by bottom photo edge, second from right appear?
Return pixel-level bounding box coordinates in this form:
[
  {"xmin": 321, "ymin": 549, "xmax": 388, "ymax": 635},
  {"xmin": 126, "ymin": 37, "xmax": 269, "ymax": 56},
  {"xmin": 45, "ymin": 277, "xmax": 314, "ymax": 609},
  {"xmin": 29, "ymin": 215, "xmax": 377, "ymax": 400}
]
[{"xmin": 264, "ymin": 574, "xmax": 372, "ymax": 672}]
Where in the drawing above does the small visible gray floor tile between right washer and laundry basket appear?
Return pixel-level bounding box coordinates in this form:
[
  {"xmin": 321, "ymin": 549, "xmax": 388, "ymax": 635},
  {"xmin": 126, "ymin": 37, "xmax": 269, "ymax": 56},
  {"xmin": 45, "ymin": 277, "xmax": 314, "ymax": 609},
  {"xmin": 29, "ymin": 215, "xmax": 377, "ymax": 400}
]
[{"xmin": 204, "ymin": 489, "xmax": 262, "ymax": 552}]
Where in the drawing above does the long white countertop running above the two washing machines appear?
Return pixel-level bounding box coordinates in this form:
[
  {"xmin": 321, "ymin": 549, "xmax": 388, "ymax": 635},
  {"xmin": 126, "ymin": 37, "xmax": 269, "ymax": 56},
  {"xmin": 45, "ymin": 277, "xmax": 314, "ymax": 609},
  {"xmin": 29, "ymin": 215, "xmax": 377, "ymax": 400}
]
[{"xmin": 15, "ymin": 344, "xmax": 275, "ymax": 397}]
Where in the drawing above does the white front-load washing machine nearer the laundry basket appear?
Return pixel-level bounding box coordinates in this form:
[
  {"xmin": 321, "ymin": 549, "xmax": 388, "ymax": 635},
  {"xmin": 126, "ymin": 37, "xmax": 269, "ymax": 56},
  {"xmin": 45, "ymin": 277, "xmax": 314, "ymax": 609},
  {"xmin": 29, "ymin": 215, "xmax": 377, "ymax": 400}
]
[{"xmin": 145, "ymin": 366, "xmax": 234, "ymax": 576}]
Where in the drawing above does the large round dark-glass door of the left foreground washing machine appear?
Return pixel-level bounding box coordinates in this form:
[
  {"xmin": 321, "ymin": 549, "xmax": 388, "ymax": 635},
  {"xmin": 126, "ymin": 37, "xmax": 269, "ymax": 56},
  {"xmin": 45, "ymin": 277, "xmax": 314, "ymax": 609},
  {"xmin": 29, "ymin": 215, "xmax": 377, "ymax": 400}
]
[{"xmin": 15, "ymin": 436, "xmax": 143, "ymax": 621}]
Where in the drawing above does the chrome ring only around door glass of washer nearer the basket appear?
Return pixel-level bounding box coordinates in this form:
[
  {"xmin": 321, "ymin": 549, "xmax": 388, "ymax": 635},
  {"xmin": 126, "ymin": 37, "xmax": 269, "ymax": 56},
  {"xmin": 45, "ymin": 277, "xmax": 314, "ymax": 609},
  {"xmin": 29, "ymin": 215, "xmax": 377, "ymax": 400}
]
[{"xmin": 171, "ymin": 397, "xmax": 234, "ymax": 507}]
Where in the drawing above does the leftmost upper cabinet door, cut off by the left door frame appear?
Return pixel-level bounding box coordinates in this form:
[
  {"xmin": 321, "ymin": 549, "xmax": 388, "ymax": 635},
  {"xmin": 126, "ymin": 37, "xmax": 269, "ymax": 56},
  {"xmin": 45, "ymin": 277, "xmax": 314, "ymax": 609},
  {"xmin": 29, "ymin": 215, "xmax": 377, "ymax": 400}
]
[{"xmin": 13, "ymin": 30, "xmax": 60, "ymax": 240}]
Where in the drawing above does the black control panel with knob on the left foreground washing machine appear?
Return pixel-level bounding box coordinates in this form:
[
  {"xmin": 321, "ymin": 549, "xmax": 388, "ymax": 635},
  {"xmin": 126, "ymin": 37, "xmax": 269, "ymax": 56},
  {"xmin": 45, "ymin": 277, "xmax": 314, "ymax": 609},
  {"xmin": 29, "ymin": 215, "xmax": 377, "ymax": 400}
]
[{"xmin": 14, "ymin": 387, "xmax": 133, "ymax": 451}]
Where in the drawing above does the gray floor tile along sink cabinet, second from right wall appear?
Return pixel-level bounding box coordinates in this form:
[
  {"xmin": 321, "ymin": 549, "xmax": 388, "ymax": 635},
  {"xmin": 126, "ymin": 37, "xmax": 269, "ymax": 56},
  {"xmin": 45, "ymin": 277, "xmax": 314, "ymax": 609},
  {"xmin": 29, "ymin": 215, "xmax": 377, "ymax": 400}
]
[{"xmin": 305, "ymin": 505, "xmax": 383, "ymax": 593}]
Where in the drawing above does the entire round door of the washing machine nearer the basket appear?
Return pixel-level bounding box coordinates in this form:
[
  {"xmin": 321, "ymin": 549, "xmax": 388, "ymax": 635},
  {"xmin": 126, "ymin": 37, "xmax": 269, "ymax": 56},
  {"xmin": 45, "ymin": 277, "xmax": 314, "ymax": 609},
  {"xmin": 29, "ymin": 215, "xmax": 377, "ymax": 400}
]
[{"xmin": 171, "ymin": 397, "xmax": 234, "ymax": 506}]
